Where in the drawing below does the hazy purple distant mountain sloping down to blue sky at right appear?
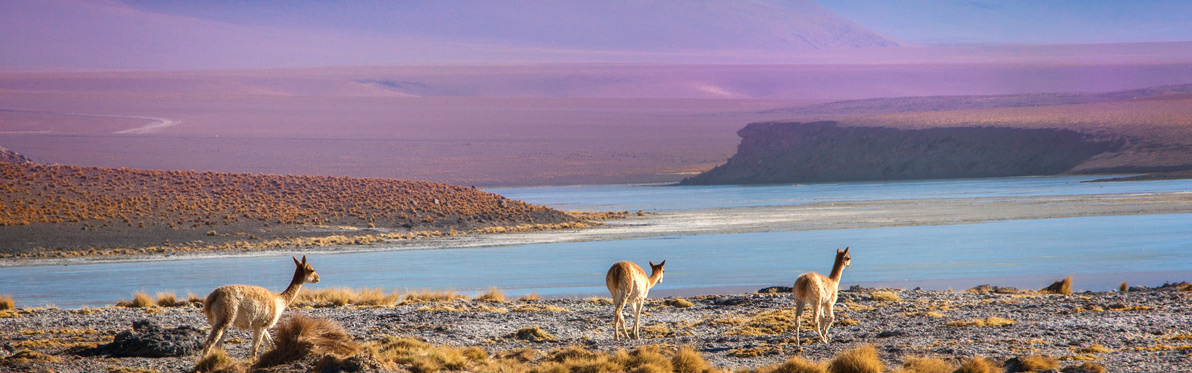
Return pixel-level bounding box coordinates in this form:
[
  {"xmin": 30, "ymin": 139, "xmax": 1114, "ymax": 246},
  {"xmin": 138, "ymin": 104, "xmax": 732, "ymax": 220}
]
[{"xmin": 0, "ymin": 0, "xmax": 902, "ymax": 69}]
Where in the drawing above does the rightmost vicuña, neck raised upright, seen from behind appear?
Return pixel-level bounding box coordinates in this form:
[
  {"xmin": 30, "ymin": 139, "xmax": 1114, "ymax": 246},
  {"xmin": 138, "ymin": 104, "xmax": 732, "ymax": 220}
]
[{"xmin": 791, "ymin": 248, "xmax": 852, "ymax": 344}]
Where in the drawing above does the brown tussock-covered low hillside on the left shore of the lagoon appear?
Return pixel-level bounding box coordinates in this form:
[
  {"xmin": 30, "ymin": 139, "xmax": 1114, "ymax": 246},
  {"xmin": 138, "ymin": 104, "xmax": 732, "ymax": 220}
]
[{"xmin": 0, "ymin": 162, "xmax": 596, "ymax": 257}]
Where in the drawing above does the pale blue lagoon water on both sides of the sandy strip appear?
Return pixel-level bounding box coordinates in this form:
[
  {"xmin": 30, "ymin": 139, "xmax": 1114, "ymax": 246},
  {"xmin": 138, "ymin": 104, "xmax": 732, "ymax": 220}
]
[{"xmin": 0, "ymin": 178, "xmax": 1192, "ymax": 307}]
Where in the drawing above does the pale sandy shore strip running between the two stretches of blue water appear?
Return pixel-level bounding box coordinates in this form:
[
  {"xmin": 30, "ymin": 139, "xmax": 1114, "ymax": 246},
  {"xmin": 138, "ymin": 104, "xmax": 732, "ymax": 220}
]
[{"xmin": 0, "ymin": 192, "xmax": 1192, "ymax": 267}]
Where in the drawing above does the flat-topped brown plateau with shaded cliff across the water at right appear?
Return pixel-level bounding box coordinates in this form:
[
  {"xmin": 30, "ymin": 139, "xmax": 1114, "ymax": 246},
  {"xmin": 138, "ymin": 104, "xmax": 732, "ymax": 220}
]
[{"xmin": 683, "ymin": 86, "xmax": 1192, "ymax": 184}]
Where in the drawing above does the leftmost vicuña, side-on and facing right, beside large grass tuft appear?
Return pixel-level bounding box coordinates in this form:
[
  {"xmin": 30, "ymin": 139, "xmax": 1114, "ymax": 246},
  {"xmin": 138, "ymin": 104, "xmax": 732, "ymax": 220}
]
[{"xmin": 200, "ymin": 255, "xmax": 318, "ymax": 358}]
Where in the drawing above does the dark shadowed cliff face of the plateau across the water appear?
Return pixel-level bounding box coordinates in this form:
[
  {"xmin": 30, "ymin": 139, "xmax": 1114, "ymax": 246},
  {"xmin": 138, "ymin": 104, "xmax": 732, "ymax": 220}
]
[{"xmin": 681, "ymin": 122, "xmax": 1124, "ymax": 185}]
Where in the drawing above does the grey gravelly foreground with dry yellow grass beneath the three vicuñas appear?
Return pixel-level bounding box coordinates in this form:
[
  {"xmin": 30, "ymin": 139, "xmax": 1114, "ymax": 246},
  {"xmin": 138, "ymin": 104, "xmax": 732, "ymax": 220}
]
[{"xmin": 0, "ymin": 287, "xmax": 1192, "ymax": 372}]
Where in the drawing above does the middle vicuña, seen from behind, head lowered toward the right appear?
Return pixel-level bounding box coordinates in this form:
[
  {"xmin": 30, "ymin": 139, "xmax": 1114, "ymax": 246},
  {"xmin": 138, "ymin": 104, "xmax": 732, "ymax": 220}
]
[{"xmin": 604, "ymin": 260, "xmax": 666, "ymax": 340}]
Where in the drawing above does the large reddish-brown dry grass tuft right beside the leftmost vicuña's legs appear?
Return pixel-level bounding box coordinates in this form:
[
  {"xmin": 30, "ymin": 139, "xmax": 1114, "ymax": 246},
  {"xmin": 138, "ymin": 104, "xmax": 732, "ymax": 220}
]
[{"xmin": 253, "ymin": 315, "xmax": 360, "ymax": 369}]
